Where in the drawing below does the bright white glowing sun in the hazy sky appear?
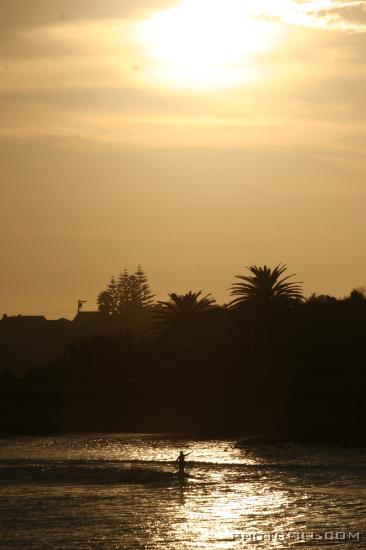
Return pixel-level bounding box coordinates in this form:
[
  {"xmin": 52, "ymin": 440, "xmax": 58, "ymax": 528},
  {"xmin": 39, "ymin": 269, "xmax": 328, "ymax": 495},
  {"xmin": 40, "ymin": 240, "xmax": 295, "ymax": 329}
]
[{"xmin": 137, "ymin": 0, "xmax": 271, "ymax": 88}]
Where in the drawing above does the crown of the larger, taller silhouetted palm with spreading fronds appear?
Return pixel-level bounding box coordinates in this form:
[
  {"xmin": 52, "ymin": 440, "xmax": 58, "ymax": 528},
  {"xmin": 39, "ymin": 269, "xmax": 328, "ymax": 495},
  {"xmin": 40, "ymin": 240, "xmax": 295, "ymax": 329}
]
[{"xmin": 230, "ymin": 264, "xmax": 303, "ymax": 307}]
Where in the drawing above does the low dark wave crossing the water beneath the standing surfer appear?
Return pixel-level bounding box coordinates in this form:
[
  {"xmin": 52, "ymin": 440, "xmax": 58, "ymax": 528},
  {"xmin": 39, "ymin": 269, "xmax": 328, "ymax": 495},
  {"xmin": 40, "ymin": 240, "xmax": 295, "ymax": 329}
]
[{"xmin": 0, "ymin": 459, "xmax": 366, "ymax": 485}]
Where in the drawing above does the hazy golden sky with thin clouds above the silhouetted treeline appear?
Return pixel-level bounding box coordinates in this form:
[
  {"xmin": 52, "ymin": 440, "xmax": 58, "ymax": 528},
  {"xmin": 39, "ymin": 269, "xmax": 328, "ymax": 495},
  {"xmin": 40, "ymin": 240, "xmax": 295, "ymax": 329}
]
[{"xmin": 0, "ymin": 0, "xmax": 366, "ymax": 318}]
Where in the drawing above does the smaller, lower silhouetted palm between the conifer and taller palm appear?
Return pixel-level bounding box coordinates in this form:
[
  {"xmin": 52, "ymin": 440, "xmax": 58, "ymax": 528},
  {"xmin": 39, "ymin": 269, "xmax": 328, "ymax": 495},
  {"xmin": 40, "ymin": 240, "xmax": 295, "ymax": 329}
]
[{"xmin": 154, "ymin": 291, "xmax": 215, "ymax": 334}]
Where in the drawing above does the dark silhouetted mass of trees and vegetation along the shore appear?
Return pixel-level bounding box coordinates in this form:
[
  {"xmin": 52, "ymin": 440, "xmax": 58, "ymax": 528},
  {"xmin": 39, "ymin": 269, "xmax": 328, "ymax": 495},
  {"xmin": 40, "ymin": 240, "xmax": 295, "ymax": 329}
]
[{"xmin": 0, "ymin": 266, "xmax": 366, "ymax": 443}]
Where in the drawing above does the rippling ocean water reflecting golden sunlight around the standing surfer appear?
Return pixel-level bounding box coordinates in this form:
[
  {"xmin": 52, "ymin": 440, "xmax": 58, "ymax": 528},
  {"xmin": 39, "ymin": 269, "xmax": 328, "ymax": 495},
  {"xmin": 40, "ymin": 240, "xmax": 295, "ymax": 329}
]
[{"xmin": 0, "ymin": 434, "xmax": 366, "ymax": 550}]
